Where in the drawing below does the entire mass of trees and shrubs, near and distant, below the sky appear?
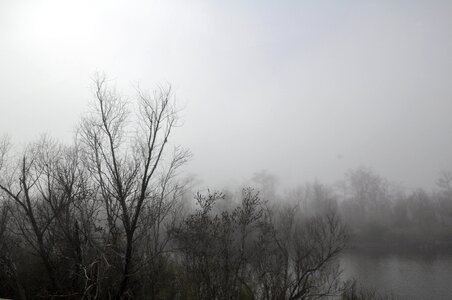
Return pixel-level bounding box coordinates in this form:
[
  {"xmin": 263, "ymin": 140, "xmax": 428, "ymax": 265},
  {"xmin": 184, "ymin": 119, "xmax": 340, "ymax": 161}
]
[{"xmin": 0, "ymin": 77, "xmax": 452, "ymax": 299}]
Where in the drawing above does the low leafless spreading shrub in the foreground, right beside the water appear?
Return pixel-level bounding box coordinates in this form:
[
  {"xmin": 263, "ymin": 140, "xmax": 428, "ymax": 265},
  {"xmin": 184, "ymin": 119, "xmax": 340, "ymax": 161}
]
[{"xmin": 254, "ymin": 205, "xmax": 347, "ymax": 300}]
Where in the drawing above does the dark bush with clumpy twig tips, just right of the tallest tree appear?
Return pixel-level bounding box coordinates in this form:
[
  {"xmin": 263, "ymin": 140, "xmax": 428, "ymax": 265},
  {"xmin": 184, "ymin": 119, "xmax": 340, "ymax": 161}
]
[{"xmin": 173, "ymin": 189, "xmax": 263, "ymax": 299}]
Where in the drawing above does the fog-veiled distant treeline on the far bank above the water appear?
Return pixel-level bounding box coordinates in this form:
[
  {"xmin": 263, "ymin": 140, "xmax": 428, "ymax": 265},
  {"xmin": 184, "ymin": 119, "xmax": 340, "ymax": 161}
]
[{"xmin": 299, "ymin": 168, "xmax": 452, "ymax": 252}]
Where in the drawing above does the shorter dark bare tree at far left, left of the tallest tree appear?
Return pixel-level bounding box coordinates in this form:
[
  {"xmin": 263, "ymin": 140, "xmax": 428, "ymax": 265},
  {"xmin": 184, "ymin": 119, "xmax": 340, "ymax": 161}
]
[{"xmin": 0, "ymin": 137, "xmax": 94, "ymax": 295}]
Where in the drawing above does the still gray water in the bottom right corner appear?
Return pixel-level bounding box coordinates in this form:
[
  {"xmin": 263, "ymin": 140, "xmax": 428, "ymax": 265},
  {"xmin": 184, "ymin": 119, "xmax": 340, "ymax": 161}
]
[{"xmin": 340, "ymin": 252, "xmax": 452, "ymax": 300}]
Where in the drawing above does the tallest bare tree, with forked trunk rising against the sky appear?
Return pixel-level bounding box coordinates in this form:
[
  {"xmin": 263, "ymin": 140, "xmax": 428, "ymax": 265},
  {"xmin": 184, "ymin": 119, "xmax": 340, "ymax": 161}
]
[{"xmin": 81, "ymin": 76, "xmax": 189, "ymax": 298}]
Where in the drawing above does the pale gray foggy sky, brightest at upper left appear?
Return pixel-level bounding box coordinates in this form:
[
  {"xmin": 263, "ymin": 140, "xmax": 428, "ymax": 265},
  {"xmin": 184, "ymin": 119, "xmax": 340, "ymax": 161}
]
[{"xmin": 0, "ymin": 0, "xmax": 452, "ymax": 187}]
